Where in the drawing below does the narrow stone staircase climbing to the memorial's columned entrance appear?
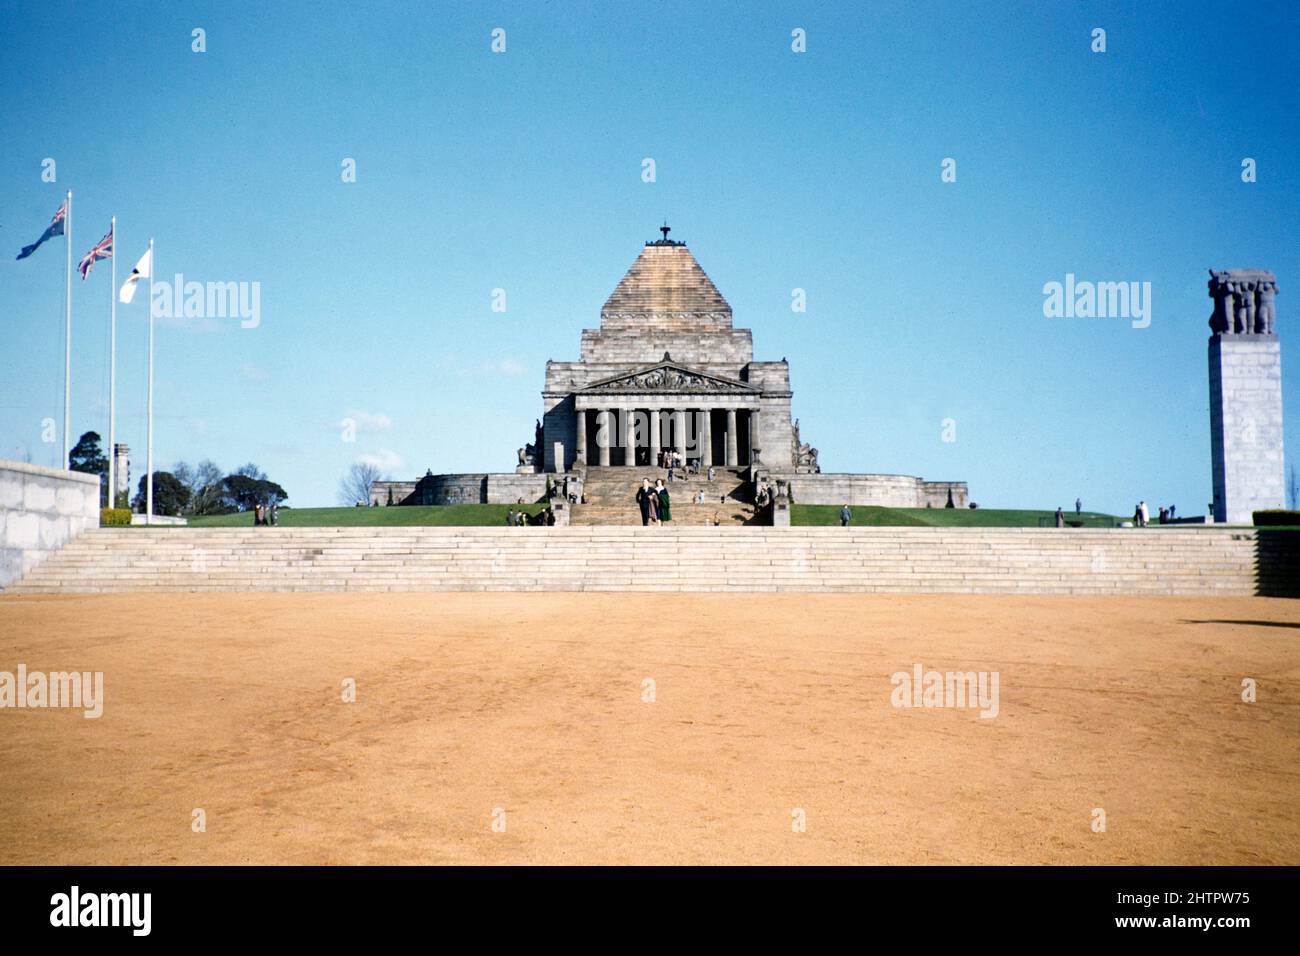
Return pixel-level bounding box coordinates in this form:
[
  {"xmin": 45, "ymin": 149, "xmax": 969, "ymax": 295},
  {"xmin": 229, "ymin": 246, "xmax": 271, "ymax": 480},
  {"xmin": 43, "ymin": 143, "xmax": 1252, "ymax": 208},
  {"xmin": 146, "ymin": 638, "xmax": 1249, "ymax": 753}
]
[{"xmin": 569, "ymin": 466, "xmax": 762, "ymax": 528}]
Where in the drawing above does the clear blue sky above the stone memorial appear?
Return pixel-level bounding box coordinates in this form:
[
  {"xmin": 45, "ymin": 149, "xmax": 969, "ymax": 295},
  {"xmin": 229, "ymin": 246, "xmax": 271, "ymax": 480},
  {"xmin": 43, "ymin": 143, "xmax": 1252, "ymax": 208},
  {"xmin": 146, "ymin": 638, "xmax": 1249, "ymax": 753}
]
[{"xmin": 0, "ymin": 0, "xmax": 1300, "ymax": 514}]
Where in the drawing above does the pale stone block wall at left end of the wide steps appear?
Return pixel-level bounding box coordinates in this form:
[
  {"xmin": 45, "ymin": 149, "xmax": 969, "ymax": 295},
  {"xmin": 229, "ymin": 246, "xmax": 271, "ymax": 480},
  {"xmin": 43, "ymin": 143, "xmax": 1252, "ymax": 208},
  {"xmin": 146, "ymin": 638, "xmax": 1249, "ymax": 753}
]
[{"xmin": 0, "ymin": 459, "xmax": 100, "ymax": 591}]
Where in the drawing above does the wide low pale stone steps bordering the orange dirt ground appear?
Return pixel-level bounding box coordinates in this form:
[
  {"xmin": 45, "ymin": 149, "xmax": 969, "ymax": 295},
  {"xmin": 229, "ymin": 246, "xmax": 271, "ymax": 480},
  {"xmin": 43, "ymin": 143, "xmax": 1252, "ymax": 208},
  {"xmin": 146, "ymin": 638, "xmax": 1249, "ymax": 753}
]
[{"xmin": 10, "ymin": 525, "xmax": 1300, "ymax": 594}]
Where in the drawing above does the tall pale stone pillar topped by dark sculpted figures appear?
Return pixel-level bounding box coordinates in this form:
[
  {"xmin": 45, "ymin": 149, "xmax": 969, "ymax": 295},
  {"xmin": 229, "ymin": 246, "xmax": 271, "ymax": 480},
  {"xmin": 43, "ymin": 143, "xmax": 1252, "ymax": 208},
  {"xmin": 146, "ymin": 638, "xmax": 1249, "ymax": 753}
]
[{"xmin": 1209, "ymin": 269, "xmax": 1286, "ymax": 524}]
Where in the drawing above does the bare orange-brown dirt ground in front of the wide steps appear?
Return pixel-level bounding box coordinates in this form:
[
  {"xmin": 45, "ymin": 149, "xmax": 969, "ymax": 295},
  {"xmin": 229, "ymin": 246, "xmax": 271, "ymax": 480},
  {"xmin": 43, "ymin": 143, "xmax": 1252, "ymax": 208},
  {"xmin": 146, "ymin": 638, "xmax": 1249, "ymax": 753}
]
[{"xmin": 0, "ymin": 594, "xmax": 1300, "ymax": 864}]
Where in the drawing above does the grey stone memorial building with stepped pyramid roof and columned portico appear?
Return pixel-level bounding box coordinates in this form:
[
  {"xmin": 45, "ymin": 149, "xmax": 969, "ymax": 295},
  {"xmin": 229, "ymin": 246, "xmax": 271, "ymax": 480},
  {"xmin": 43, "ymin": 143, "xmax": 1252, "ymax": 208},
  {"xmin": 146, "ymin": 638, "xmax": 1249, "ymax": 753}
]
[{"xmin": 372, "ymin": 226, "xmax": 967, "ymax": 523}]
